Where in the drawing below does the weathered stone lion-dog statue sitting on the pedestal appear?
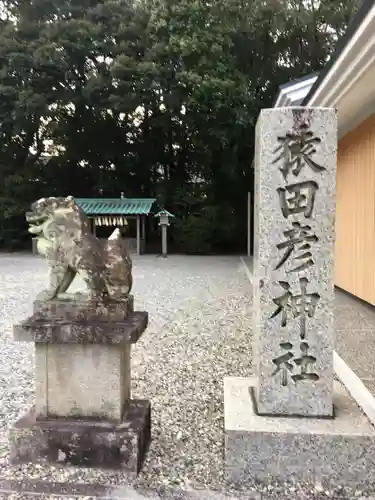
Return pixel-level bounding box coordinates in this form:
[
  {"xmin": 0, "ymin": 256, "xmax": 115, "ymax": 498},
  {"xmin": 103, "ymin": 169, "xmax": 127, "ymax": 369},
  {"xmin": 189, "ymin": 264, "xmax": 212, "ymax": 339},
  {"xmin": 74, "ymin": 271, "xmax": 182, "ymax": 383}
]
[{"xmin": 26, "ymin": 196, "xmax": 132, "ymax": 300}]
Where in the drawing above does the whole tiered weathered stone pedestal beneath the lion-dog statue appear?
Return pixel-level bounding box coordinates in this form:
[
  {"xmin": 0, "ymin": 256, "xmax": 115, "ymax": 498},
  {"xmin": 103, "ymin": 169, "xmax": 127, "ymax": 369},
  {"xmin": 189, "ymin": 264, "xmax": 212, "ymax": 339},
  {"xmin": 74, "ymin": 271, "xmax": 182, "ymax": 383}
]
[{"xmin": 10, "ymin": 294, "xmax": 150, "ymax": 473}]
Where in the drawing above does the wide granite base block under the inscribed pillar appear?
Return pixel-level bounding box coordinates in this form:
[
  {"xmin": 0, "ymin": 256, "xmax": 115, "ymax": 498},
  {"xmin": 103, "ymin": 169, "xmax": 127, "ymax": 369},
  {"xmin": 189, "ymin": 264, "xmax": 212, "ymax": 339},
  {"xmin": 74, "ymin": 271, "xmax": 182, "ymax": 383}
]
[{"xmin": 224, "ymin": 377, "xmax": 375, "ymax": 487}]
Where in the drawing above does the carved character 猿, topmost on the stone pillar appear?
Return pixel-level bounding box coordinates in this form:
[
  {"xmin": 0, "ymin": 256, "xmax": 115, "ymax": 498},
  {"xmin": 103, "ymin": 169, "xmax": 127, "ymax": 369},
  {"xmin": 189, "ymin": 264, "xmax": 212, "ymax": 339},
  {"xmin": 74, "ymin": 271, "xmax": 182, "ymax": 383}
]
[{"xmin": 272, "ymin": 127, "xmax": 325, "ymax": 181}]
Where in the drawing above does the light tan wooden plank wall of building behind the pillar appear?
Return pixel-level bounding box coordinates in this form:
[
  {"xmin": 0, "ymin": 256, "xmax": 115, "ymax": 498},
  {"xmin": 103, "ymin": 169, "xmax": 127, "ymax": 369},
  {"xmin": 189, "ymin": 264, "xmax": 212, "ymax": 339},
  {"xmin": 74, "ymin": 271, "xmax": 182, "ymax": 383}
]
[{"xmin": 335, "ymin": 115, "xmax": 375, "ymax": 305}]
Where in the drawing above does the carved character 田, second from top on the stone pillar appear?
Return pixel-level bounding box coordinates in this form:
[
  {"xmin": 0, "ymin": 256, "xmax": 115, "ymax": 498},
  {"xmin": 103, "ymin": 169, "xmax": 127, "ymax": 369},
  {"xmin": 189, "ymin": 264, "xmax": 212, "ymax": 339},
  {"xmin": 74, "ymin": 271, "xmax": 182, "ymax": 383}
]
[{"xmin": 277, "ymin": 181, "xmax": 318, "ymax": 219}]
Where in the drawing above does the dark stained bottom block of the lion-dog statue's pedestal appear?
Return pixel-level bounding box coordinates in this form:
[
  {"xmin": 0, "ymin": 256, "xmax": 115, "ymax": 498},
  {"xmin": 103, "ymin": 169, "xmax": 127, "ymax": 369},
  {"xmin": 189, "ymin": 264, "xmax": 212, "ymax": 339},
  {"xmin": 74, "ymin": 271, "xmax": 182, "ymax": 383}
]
[{"xmin": 9, "ymin": 400, "xmax": 151, "ymax": 475}]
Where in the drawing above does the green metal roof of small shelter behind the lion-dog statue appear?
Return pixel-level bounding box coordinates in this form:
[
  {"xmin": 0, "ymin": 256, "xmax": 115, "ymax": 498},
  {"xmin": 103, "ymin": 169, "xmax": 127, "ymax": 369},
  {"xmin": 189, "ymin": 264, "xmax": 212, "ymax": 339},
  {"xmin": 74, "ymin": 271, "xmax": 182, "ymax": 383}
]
[{"xmin": 75, "ymin": 198, "xmax": 156, "ymax": 215}]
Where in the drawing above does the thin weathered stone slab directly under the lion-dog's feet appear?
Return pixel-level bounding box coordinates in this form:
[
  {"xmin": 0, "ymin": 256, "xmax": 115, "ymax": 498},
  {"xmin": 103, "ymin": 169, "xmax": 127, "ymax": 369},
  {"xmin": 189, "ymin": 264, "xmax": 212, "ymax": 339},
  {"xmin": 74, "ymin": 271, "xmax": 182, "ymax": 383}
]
[{"xmin": 34, "ymin": 293, "xmax": 134, "ymax": 323}]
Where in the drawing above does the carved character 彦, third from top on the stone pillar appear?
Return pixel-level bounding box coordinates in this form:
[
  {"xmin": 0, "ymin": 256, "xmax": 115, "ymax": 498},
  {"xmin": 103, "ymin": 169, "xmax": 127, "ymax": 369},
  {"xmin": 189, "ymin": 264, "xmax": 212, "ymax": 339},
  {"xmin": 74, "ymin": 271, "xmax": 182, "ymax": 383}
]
[{"xmin": 275, "ymin": 222, "xmax": 318, "ymax": 273}]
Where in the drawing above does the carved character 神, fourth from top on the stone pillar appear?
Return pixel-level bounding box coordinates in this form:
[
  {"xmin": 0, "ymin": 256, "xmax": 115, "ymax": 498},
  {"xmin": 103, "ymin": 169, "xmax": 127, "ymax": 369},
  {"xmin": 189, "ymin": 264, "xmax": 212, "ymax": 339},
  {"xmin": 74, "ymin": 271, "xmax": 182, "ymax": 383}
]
[{"xmin": 271, "ymin": 277, "xmax": 320, "ymax": 339}]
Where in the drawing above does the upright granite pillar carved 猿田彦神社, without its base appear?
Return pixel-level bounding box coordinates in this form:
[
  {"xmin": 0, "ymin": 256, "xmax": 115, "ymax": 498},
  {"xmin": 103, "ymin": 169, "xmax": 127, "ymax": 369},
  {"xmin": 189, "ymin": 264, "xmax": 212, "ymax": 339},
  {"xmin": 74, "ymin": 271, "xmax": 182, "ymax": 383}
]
[{"xmin": 254, "ymin": 108, "xmax": 337, "ymax": 417}]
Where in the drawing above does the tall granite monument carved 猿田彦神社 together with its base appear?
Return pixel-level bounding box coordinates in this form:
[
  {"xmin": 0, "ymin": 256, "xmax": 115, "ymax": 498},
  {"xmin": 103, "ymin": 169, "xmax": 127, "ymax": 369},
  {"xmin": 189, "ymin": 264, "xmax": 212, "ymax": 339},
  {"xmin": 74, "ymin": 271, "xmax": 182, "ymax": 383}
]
[{"xmin": 224, "ymin": 108, "xmax": 375, "ymax": 482}]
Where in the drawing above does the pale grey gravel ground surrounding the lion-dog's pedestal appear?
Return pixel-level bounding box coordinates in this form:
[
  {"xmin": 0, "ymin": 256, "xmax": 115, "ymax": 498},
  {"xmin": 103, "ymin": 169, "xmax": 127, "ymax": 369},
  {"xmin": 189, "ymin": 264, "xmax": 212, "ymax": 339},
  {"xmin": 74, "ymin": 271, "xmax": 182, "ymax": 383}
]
[{"xmin": 0, "ymin": 254, "xmax": 375, "ymax": 500}]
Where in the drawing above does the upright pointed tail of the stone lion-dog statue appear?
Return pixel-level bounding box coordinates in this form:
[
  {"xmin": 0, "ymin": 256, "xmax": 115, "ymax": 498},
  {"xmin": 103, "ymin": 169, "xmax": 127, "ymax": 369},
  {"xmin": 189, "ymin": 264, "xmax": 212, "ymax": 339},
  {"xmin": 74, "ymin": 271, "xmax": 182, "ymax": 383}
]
[{"xmin": 105, "ymin": 229, "xmax": 133, "ymax": 299}]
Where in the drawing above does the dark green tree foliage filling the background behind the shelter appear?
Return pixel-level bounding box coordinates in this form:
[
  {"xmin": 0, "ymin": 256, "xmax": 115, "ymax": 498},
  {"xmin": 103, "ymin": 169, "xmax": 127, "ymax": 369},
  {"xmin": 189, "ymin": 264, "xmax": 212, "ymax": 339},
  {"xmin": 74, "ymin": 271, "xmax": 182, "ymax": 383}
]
[{"xmin": 0, "ymin": 0, "xmax": 360, "ymax": 252}]
